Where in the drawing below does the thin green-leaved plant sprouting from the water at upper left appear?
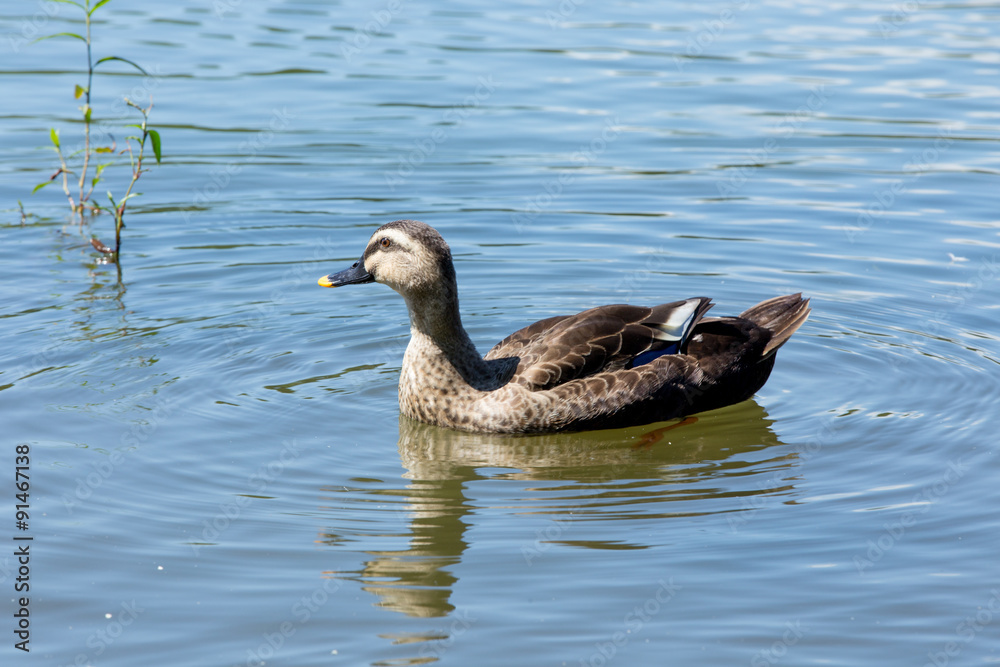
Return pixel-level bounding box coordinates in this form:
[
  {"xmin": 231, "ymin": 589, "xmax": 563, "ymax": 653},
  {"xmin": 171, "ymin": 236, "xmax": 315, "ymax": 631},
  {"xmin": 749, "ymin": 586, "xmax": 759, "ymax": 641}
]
[{"xmin": 32, "ymin": 0, "xmax": 162, "ymax": 263}]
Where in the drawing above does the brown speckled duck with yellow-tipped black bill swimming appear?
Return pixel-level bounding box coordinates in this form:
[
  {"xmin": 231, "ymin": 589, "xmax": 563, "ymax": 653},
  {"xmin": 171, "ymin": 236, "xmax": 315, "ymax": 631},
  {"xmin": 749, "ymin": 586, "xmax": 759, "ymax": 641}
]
[{"xmin": 319, "ymin": 220, "xmax": 810, "ymax": 434}]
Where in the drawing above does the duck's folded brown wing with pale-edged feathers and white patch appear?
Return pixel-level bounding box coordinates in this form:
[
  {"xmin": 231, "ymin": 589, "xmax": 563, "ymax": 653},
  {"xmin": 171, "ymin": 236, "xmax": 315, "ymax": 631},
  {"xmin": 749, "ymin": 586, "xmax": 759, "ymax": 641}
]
[{"xmin": 486, "ymin": 297, "xmax": 712, "ymax": 391}]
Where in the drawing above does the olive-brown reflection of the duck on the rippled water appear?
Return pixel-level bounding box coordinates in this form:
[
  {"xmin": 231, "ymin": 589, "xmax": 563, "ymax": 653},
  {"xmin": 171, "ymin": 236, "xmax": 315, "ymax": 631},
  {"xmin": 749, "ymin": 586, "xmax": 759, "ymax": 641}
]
[{"xmin": 332, "ymin": 401, "xmax": 797, "ymax": 617}]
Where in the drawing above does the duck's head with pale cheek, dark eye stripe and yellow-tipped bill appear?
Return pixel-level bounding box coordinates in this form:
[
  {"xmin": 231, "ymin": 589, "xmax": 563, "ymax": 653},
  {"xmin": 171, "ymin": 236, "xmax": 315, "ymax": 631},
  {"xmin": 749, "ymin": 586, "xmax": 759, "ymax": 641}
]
[{"xmin": 319, "ymin": 220, "xmax": 455, "ymax": 297}]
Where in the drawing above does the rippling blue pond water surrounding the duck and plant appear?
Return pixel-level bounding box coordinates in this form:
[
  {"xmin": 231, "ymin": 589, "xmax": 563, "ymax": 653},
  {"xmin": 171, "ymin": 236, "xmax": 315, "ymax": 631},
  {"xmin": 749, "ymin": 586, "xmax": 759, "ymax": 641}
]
[{"xmin": 0, "ymin": 0, "xmax": 1000, "ymax": 667}]
